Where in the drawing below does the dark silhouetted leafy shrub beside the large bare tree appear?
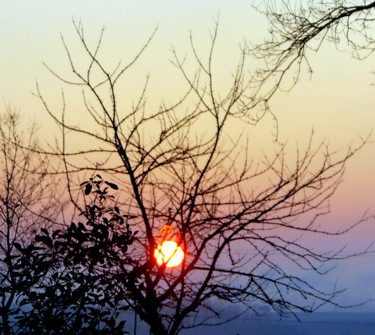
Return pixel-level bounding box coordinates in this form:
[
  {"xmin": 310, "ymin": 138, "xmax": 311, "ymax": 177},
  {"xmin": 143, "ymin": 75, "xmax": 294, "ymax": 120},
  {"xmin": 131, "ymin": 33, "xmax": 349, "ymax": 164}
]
[{"xmin": 3, "ymin": 176, "xmax": 135, "ymax": 334}]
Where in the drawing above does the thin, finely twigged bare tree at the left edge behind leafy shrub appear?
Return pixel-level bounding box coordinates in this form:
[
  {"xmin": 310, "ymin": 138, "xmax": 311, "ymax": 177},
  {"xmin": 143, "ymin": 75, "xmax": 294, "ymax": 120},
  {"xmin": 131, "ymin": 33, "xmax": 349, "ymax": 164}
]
[{"xmin": 0, "ymin": 106, "xmax": 59, "ymax": 334}]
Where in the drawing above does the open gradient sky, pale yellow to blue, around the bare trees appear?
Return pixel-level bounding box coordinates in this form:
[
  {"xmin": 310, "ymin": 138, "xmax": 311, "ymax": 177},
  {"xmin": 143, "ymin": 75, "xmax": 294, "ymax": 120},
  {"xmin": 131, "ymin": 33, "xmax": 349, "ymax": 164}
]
[{"xmin": 0, "ymin": 0, "xmax": 375, "ymax": 310}]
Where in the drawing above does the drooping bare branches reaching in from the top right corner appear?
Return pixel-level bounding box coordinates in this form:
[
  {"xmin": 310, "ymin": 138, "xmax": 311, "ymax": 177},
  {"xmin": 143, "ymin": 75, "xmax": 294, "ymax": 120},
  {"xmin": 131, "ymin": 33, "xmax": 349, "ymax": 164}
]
[{"xmin": 248, "ymin": 0, "xmax": 375, "ymax": 99}]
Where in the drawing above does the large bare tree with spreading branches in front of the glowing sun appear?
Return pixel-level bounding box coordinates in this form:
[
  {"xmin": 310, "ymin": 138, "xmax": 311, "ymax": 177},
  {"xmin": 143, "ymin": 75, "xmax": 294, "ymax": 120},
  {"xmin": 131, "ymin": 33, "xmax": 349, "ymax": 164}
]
[{"xmin": 36, "ymin": 23, "xmax": 374, "ymax": 335}]
